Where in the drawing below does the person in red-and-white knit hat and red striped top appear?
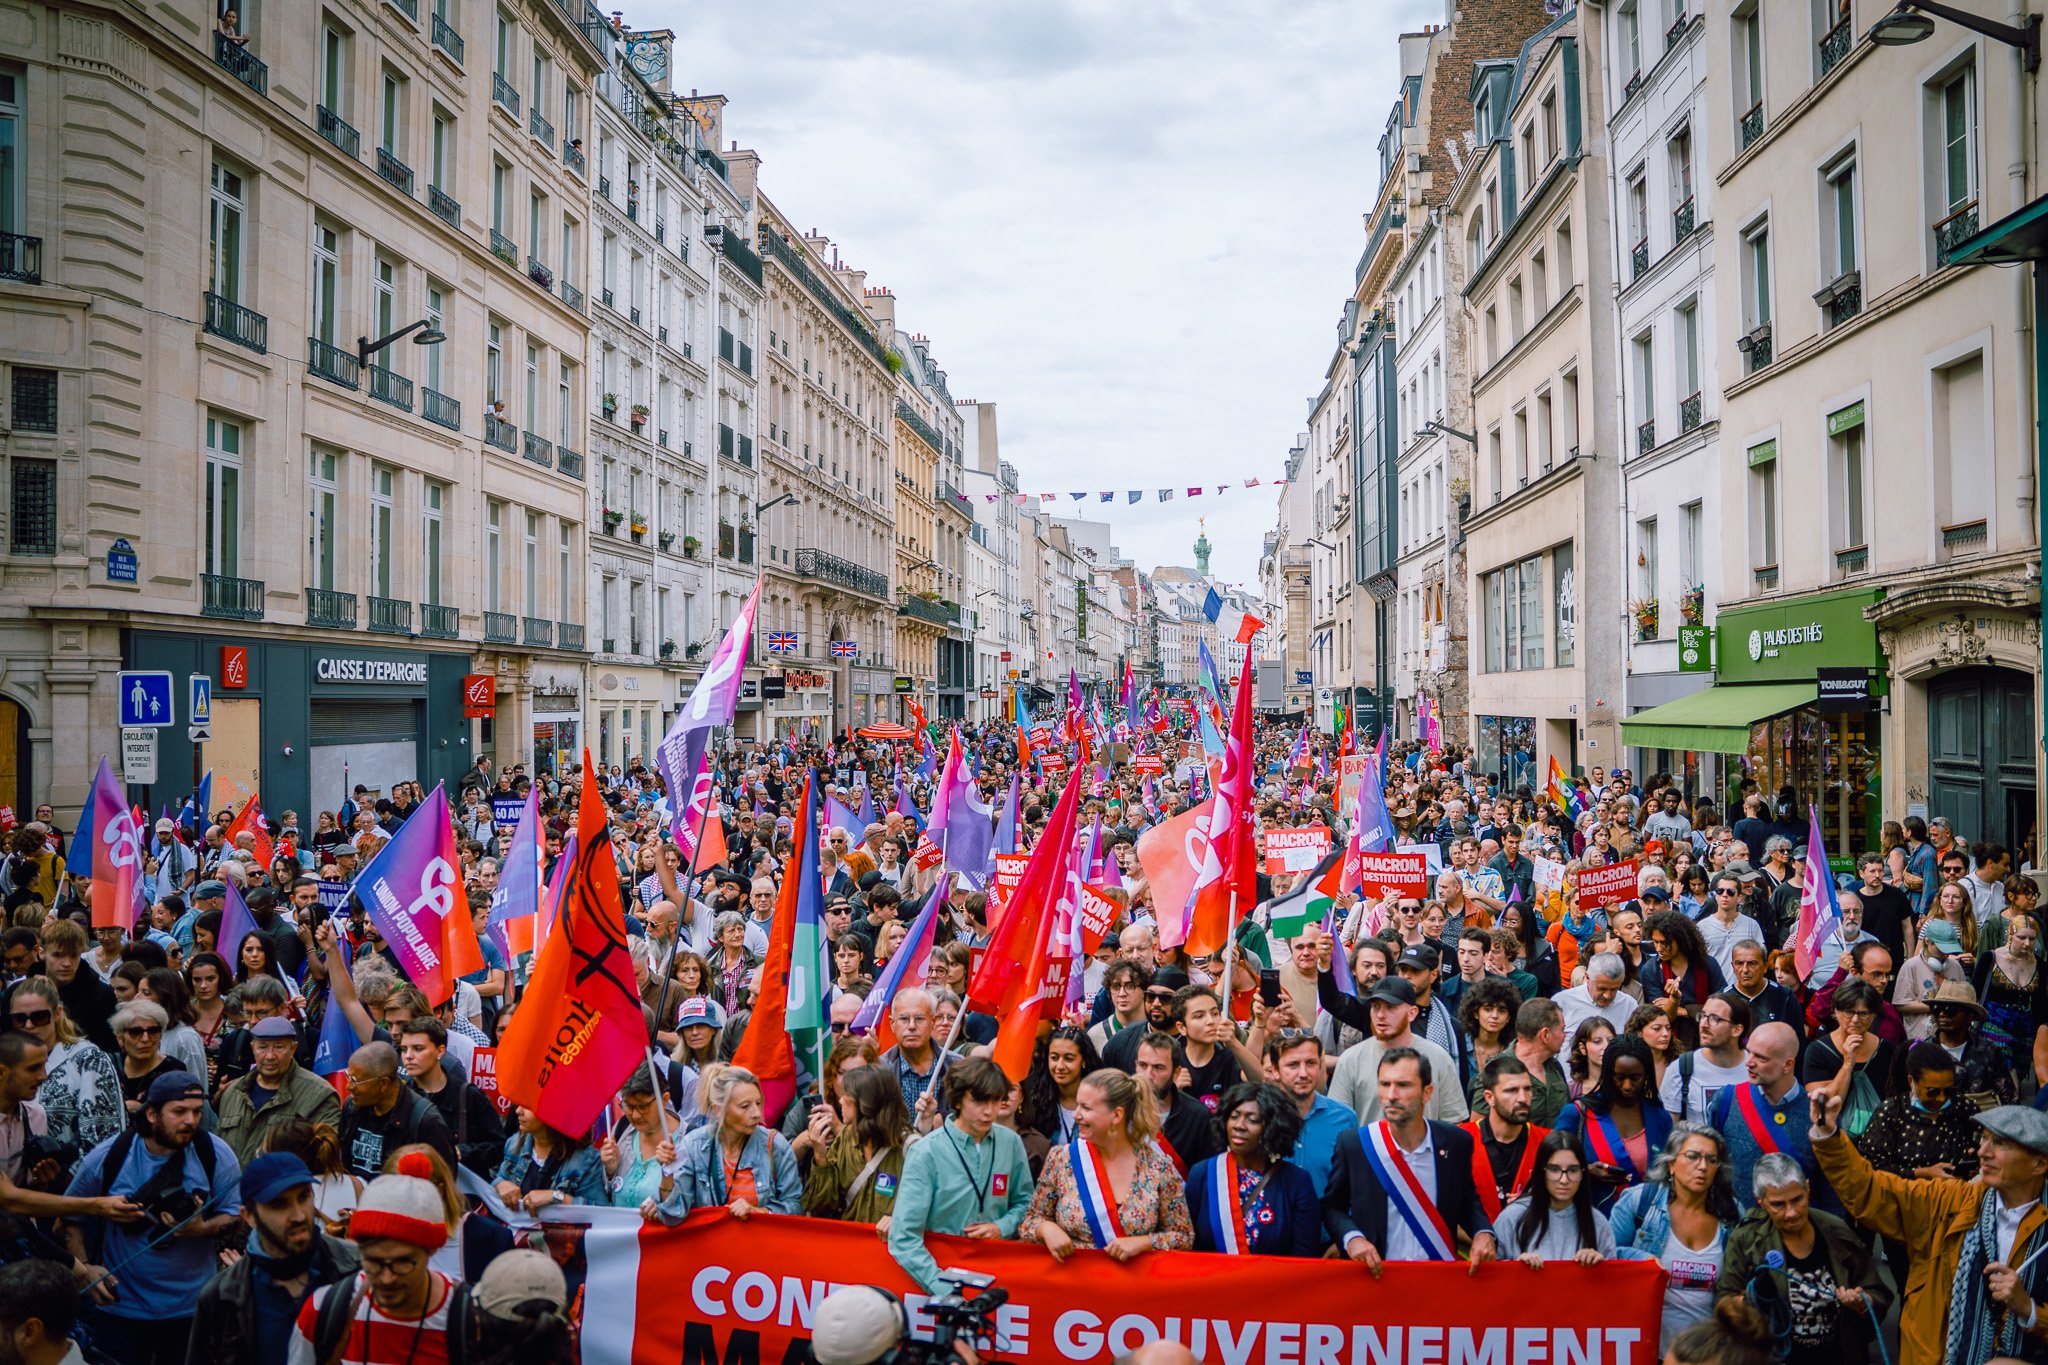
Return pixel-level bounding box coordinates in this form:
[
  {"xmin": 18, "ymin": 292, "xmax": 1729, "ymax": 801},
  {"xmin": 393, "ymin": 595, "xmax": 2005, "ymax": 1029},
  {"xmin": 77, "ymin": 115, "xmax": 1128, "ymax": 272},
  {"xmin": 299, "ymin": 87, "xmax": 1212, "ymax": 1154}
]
[{"xmin": 285, "ymin": 1152, "xmax": 467, "ymax": 1365}]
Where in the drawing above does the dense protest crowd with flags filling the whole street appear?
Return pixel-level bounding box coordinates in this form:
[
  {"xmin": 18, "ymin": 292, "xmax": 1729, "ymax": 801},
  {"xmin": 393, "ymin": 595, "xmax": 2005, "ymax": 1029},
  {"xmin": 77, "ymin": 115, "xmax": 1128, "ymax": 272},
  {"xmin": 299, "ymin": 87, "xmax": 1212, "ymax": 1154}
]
[{"xmin": 0, "ymin": 593, "xmax": 2048, "ymax": 1365}]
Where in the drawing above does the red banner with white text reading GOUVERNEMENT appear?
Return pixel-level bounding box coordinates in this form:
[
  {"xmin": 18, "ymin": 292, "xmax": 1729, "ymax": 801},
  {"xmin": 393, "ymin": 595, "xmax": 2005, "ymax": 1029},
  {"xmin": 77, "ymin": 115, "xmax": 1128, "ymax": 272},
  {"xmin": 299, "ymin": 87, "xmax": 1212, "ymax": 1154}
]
[{"xmin": 584, "ymin": 1209, "xmax": 1663, "ymax": 1365}]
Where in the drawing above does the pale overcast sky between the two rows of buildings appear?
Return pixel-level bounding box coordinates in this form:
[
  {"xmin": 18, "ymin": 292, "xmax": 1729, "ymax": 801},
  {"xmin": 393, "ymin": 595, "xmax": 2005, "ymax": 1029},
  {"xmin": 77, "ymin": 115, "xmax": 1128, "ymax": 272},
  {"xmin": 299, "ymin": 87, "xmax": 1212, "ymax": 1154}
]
[{"xmin": 647, "ymin": 0, "xmax": 1442, "ymax": 581}]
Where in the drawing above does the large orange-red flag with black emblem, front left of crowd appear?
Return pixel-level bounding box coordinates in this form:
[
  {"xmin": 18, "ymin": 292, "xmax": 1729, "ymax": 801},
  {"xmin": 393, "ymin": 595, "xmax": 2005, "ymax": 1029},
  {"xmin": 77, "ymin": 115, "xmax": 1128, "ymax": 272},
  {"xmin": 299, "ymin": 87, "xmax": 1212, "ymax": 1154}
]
[{"xmin": 498, "ymin": 749, "xmax": 647, "ymax": 1134}]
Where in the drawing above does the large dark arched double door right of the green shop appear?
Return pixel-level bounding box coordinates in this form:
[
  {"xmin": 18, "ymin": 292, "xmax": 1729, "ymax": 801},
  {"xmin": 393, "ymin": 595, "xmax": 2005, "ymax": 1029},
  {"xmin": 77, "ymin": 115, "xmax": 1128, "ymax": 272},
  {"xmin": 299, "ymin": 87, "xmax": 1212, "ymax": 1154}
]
[{"xmin": 1927, "ymin": 667, "xmax": 2036, "ymax": 847}]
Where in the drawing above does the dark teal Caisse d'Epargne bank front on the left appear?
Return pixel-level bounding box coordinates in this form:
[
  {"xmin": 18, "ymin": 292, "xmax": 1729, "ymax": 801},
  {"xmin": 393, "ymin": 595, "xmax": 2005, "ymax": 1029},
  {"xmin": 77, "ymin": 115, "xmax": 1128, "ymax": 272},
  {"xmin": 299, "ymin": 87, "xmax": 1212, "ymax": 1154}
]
[{"xmin": 125, "ymin": 630, "xmax": 475, "ymax": 829}]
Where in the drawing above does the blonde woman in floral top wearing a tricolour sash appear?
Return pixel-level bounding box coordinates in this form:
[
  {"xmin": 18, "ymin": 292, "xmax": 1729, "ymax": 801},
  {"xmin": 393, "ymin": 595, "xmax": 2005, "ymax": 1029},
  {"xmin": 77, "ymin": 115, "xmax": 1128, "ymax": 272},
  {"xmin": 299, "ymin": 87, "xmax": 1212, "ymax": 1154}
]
[{"xmin": 1020, "ymin": 1066, "xmax": 1194, "ymax": 1261}]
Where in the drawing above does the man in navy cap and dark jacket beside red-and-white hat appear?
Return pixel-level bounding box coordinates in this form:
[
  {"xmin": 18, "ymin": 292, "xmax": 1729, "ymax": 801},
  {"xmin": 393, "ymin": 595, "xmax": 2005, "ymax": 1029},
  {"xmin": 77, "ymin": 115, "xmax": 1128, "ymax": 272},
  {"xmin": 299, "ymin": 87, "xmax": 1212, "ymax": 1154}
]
[{"xmin": 186, "ymin": 1154, "xmax": 362, "ymax": 1365}]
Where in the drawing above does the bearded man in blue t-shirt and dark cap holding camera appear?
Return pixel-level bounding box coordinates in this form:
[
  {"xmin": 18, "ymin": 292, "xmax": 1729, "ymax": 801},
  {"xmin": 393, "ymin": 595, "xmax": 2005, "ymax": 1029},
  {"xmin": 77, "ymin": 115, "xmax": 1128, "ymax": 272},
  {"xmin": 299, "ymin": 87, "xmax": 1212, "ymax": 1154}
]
[{"xmin": 63, "ymin": 1070, "xmax": 242, "ymax": 1365}]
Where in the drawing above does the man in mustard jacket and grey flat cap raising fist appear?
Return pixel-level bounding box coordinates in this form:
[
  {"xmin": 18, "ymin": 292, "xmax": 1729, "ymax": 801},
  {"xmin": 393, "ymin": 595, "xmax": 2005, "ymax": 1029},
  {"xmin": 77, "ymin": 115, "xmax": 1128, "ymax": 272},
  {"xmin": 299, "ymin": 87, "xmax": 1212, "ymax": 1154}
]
[{"xmin": 1810, "ymin": 1089, "xmax": 2048, "ymax": 1365}]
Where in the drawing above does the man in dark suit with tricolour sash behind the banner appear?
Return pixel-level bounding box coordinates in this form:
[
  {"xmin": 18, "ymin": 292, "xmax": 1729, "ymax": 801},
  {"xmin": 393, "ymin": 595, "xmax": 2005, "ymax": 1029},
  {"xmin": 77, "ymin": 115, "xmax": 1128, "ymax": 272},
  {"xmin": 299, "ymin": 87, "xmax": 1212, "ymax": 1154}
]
[{"xmin": 1323, "ymin": 1048, "xmax": 1499, "ymax": 1277}]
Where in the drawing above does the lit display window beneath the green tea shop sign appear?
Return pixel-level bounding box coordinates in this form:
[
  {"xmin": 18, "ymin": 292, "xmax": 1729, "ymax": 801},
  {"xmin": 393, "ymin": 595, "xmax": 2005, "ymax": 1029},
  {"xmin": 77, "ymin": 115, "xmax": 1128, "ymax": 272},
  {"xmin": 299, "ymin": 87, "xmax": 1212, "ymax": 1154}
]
[{"xmin": 1724, "ymin": 706, "xmax": 1882, "ymax": 872}]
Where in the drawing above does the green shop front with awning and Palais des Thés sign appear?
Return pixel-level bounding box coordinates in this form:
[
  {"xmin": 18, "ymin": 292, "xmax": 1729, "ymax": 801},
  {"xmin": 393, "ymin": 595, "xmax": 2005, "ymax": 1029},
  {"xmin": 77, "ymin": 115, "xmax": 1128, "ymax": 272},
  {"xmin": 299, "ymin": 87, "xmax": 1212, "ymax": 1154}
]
[{"xmin": 1622, "ymin": 587, "xmax": 1886, "ymax": 868}]
